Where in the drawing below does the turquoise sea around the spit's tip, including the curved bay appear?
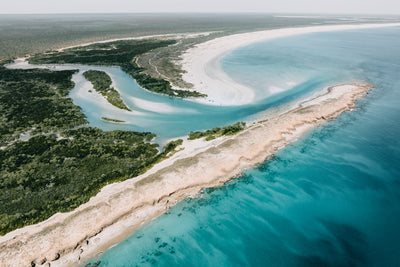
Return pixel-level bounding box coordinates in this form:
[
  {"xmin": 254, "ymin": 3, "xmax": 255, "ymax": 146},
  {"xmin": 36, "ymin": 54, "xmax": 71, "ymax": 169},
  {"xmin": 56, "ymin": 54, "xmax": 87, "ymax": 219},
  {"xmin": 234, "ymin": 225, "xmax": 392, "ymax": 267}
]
[{"xmin": 83, "ymin": 27, "xmax": 400, "ymax": 266}]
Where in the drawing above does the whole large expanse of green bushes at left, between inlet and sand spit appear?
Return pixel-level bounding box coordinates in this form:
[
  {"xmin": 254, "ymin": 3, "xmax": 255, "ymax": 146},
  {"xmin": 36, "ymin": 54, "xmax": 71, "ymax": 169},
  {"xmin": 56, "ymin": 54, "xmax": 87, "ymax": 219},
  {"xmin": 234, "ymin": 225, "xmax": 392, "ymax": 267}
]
[{"xmin": 0, "ymin": 66, "xmax": 182, "ymax": 235}]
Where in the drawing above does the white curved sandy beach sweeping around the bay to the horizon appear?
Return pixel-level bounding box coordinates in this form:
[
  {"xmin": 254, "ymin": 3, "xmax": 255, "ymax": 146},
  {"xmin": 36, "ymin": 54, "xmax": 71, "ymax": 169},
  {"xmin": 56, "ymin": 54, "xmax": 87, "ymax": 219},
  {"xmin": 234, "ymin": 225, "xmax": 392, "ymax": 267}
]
[{"xmin": 176, "ymin": 23, "xmax": 400, "ymax": 106}]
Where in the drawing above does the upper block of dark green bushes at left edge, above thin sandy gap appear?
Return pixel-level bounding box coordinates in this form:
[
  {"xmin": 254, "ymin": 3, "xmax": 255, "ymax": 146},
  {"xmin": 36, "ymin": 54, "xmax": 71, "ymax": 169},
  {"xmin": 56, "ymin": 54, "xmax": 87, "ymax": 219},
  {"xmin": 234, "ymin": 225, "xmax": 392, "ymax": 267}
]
[{"xmin": 0, "ymin": 66, "xmax": 87, "ymax": 146}]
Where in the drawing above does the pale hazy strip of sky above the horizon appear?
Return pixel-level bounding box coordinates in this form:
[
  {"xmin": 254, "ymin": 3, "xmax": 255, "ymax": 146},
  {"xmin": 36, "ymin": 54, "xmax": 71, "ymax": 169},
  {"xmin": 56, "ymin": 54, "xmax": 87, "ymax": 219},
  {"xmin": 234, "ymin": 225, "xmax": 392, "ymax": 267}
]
[{"xmin": 0, "ymin": 0, "xmax": 400, "ymax": 14}]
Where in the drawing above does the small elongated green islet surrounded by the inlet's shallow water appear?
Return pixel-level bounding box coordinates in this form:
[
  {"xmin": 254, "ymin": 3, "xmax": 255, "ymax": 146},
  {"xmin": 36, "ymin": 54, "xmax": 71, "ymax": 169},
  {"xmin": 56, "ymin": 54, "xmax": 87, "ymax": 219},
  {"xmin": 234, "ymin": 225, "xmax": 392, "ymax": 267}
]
[{"xmin": 83, "ymin": 70, "xmax": 130, "ymax": 111}]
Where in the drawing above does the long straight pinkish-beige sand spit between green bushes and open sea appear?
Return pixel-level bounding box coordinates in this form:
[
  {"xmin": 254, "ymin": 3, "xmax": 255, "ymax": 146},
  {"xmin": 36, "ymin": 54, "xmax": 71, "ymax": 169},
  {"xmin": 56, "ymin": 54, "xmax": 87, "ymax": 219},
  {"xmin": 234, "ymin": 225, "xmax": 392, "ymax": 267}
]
[{"xmin": 0, "ymin": 82, "xmax": 372, "ymax": 266}]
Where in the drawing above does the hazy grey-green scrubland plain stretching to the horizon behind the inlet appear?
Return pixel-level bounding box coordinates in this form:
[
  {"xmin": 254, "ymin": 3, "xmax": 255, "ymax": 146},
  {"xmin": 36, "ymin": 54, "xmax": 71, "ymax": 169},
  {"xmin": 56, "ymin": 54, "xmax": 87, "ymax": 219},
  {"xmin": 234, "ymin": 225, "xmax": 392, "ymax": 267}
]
[{"xmin": 0, "ymin": 13, "xmax": 354, "ymax": 59}]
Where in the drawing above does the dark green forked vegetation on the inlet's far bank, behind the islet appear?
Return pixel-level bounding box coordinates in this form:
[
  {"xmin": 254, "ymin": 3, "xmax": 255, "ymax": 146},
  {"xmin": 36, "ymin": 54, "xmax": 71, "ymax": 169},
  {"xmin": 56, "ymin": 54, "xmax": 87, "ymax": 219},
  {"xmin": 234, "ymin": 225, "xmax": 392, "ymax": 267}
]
[{"xmin": 29, "ymin": 40, "xmax": 205, "ymax": 97}]
